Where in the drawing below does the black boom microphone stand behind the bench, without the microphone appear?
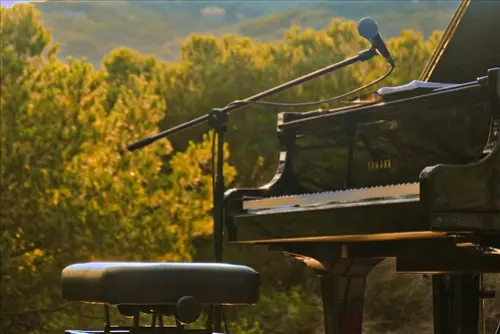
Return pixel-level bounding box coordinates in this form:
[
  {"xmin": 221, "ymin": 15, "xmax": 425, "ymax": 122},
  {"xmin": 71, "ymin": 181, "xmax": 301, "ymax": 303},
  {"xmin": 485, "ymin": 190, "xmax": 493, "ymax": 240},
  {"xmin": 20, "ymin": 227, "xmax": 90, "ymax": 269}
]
[{"xmin": 128, "ymin": 48, "xmax": 377, "ymax": 332}]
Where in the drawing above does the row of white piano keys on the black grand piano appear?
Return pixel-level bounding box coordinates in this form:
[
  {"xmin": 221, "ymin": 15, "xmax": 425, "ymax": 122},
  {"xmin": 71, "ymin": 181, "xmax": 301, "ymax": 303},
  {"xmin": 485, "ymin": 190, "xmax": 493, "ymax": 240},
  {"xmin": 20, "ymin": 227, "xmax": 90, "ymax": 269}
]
[{"xmin": 243, "ymin": 183, "xmax": 420, "ymax": 210}]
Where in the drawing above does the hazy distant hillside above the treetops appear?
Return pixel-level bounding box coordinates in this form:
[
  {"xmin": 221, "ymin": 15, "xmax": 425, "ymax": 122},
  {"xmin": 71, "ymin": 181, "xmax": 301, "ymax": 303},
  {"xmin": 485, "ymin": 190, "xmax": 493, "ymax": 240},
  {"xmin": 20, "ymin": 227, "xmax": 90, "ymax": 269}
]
[{"xmin": 36, "ymin": 0, "xmax": 459, "ymax": 65}]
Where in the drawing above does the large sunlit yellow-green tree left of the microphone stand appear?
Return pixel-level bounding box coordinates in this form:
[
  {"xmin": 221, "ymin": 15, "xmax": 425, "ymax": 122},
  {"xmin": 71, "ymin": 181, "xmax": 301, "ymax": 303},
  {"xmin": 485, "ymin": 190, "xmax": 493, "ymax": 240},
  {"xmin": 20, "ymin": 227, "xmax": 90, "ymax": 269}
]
[{"xmin": 0, "ymin": 5, "xmax": 235, "ymax": 333}]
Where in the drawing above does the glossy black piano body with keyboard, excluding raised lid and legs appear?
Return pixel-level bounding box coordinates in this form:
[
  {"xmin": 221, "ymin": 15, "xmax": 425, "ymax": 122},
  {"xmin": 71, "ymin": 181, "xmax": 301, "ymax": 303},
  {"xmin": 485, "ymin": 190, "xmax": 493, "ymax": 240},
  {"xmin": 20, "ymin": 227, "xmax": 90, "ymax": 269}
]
[{"xmin": 227, "ymin": 69, "xmax": 500, "ymax": 249}]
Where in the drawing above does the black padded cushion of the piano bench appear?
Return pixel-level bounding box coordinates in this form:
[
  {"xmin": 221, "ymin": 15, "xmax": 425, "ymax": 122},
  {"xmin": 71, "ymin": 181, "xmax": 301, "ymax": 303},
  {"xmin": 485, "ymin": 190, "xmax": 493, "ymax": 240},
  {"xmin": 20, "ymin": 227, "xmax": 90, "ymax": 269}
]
[{"xmin": 61, "ymin": 262, "xmax": 260, "ymax": 305}]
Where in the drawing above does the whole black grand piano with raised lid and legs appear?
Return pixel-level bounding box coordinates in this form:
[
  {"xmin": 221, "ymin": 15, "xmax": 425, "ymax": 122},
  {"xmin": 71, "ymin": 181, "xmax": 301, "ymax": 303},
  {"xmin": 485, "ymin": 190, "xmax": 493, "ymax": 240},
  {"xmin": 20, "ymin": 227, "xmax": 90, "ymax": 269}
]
[{"xmin": 225, "ymin": 0, "xmax": 500, "ymax": 334}]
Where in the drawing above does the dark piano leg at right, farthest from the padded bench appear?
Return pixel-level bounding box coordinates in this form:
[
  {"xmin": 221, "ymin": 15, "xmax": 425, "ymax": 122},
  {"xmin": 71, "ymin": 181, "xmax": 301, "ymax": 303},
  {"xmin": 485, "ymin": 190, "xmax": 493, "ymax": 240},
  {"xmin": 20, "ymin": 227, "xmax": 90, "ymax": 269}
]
[{"xmin": 432, "ymin": 274, "xmax": 480, "ymax": 334}]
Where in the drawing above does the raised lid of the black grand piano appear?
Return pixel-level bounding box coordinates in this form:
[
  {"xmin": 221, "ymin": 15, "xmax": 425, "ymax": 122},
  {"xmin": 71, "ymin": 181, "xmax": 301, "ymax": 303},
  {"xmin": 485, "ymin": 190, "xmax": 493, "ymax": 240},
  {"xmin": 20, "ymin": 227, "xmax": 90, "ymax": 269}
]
[{"xmin": 420, "ymin": 0, "xmax": 500, "ymax": 83}]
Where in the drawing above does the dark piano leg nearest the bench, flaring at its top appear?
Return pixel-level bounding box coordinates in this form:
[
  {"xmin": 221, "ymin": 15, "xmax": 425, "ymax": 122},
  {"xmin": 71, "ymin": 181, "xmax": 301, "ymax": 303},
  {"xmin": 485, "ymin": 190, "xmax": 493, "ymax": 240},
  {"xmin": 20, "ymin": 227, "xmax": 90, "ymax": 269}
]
[{"xmin": 319, "ymin": 259, "xmax": 380, "ymax": 334}]
